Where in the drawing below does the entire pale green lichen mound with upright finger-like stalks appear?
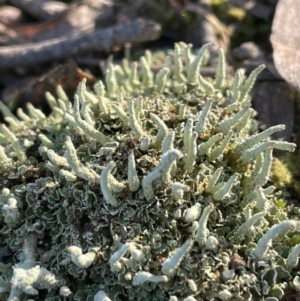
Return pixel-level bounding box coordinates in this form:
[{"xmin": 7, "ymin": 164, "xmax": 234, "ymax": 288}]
[{"xmin": 0, "ymin": 43, "xmax": 300, "ymax": 301}]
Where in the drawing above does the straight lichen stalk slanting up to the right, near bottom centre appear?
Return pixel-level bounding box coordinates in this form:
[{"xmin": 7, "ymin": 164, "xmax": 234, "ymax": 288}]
[{"xmin": 161, "ymin": 239, "xmax": 194, "ymax": 275}]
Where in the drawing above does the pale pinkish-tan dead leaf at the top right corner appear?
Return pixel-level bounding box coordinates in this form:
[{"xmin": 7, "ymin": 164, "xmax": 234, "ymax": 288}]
[{"xmin": 271, "ymin": 0, "xmax": 300, "ymax": 91}]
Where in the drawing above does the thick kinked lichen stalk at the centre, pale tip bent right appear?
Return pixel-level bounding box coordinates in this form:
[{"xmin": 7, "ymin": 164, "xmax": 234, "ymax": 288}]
[{"xmin": 142, "ymin": 149, "xmax": 182, "ymax": 200}]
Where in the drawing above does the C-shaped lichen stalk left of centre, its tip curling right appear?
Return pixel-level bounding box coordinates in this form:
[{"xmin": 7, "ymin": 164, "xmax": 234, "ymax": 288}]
[{"xmin": 100, "ymin": 161, "xmax": 119, "ymax": 207}]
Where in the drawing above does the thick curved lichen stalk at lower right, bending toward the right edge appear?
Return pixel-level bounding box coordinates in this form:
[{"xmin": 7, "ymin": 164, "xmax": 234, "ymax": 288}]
[{"xmin": 251, "ymin": 220, "xmax": 300, "ymax": 261}]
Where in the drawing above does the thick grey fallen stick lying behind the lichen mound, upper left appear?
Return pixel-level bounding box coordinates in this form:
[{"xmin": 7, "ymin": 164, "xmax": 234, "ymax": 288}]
[{"xmin": 0, "ymin": 19, "xmax": 161, "ymax": 68}]
